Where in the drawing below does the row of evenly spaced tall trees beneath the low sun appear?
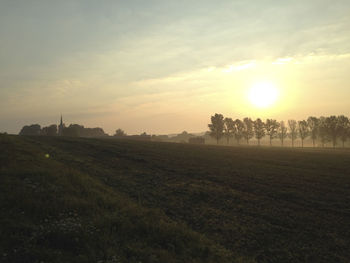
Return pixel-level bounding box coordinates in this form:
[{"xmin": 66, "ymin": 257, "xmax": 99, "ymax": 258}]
[{"xmin": 208, "ymin": 113, "xmax": 350, "ymax": 147}]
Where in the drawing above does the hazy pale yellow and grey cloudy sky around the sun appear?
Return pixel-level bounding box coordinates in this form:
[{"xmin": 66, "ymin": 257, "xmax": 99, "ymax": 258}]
[{"xmin": 0, "ymin": 0, "xmax": 350, "ymax": 134}]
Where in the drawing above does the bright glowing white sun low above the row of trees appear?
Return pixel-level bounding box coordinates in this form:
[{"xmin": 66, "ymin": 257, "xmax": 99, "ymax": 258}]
[{"xmin": 248, "ymin": 82, "xmax": 279, "ymax": 108}]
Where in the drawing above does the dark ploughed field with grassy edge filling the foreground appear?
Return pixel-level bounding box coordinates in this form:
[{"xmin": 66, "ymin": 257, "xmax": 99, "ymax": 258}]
[{"xmin": 0, "ymin": 136, "xmax": 350, "ymax": 263}]
